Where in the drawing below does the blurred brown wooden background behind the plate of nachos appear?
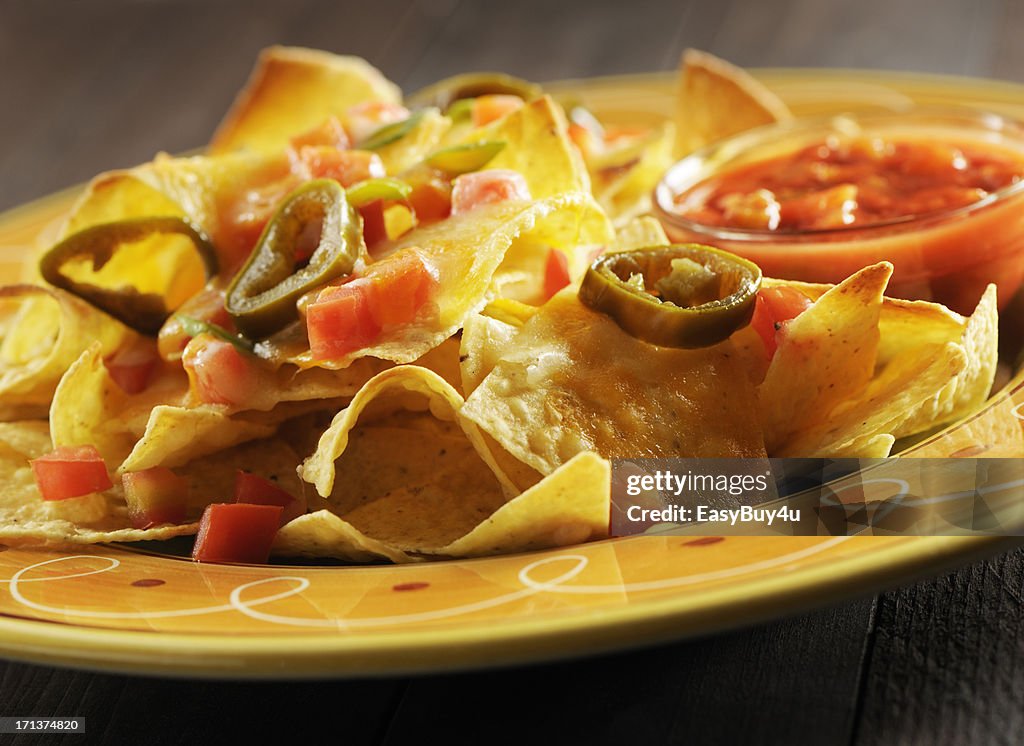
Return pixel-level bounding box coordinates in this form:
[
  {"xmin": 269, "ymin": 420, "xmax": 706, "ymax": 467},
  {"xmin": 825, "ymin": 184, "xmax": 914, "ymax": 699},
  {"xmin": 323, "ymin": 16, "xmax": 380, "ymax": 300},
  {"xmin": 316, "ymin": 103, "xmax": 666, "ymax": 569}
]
[{"xmin": 0, "ymin": 0, "xmax": 1024, "ymax": 210}]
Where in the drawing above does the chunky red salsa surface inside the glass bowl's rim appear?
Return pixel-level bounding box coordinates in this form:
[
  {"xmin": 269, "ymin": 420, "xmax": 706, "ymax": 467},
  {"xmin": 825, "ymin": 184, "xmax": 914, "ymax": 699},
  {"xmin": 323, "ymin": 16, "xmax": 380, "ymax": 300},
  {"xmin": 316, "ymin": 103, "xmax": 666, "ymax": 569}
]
[{"xmin": 676, "ymin": 135, "xmax": 1024, "ymax": 232}]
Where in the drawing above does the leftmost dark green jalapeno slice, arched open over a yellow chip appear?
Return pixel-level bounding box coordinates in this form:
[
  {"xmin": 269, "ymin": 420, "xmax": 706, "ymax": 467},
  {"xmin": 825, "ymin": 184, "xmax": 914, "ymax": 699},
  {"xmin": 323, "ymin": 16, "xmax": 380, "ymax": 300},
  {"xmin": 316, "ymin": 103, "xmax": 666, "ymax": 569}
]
[{"xmin": 39, "ymin": 216, "xmax": 217, "ymax": 335}]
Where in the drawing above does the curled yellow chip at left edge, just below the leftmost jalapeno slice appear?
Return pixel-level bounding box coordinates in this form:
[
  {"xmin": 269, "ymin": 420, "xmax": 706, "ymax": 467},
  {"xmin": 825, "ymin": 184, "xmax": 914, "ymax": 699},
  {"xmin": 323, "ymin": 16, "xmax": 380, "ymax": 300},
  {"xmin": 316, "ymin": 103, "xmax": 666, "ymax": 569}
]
[{"xmin": 0, "ymin": 286, "xmax": 137, "ymax": 419}]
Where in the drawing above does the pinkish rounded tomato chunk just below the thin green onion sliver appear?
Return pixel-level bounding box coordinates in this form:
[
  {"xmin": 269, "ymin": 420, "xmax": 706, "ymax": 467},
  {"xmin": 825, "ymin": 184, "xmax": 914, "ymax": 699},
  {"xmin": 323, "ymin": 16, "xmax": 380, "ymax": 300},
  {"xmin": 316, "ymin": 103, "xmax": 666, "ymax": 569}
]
[{"xmin": 181, "ymin": 334, "xmax": 260, "ymax": 406}]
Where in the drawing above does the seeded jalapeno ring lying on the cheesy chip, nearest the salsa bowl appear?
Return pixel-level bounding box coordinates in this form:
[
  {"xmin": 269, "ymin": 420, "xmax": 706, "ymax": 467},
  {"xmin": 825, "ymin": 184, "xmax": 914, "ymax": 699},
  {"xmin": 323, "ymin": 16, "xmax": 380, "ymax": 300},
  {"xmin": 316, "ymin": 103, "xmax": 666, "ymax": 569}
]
[{"xmin": 580, "ymin": 244, "xmax": 761, "ymax": 348}]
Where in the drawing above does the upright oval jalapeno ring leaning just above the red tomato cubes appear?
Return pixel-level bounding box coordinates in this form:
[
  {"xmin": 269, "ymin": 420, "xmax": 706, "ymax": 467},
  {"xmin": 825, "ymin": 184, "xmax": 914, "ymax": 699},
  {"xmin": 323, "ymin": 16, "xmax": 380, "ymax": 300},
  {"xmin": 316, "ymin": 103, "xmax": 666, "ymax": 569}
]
[{"xmin": 224, "ymin": 179, "xmax": 365, "ymax": 339}]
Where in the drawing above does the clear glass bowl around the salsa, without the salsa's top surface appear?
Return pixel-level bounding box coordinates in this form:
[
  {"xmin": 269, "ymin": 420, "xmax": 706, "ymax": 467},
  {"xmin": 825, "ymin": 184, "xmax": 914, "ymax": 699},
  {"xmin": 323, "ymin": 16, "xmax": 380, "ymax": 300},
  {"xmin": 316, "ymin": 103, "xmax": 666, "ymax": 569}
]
[{"xmin": 652, "ymin": 108, "xmax": 1024, "ymax": 314}]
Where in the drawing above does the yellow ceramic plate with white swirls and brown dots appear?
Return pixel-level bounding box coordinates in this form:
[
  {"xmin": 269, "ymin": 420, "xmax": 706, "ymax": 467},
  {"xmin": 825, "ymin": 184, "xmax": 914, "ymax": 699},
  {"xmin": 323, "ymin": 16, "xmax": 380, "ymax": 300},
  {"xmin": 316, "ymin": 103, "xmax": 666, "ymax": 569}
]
[{"xmin": 0, "ymin": 71, "xmax": 1024, "ymax": 677}]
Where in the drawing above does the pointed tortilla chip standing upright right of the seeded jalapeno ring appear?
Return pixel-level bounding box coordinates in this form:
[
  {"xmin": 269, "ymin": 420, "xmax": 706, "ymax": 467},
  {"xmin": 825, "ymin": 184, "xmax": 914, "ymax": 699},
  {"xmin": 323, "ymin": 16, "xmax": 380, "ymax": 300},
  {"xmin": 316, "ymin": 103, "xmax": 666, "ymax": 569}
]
[{"xmin": 758, "ymin": 262, "xmax": 892, "ymax": 455}]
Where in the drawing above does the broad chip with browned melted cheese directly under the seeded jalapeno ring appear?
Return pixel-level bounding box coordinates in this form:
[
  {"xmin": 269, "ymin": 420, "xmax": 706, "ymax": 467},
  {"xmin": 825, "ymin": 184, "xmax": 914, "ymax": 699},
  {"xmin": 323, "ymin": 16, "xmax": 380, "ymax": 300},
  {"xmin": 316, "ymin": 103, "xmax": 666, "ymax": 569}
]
[{"xmin": 462, "ymin": 289, "xmax": 764, "ymax": 474}]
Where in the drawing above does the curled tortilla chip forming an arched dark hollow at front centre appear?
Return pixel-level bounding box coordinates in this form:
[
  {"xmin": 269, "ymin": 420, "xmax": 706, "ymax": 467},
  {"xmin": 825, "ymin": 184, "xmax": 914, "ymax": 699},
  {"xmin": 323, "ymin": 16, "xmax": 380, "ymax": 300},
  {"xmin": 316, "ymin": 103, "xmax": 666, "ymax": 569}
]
[{"xmin": 299, "ymin": 365, "xmax": 544, "ymax": 552}]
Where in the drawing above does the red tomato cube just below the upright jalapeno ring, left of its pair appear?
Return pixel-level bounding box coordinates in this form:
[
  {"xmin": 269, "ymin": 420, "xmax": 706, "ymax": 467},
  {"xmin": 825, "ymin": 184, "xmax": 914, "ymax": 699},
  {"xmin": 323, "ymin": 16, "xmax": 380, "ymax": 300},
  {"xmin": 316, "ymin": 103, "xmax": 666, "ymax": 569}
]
[{"xmin": 306, "ymin": 278, "xmax": 381, "ymax": 360}]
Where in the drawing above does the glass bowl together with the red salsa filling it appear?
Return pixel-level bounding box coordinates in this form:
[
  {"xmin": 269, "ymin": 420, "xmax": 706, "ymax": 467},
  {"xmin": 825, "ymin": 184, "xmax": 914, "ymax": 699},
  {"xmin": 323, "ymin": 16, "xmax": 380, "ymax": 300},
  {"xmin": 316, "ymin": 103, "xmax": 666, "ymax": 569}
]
[{"xmin": 654, "ymin": 109, "xmax": 1024, "ymax": 313}]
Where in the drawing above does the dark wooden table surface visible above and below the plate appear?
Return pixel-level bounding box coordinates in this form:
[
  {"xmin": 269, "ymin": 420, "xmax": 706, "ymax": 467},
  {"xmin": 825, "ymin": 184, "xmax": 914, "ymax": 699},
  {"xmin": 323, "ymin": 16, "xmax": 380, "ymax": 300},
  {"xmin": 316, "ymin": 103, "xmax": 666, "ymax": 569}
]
[{"xmin": 0, "ymin": 0, "xmax": 1024, "ymax": 746}]
